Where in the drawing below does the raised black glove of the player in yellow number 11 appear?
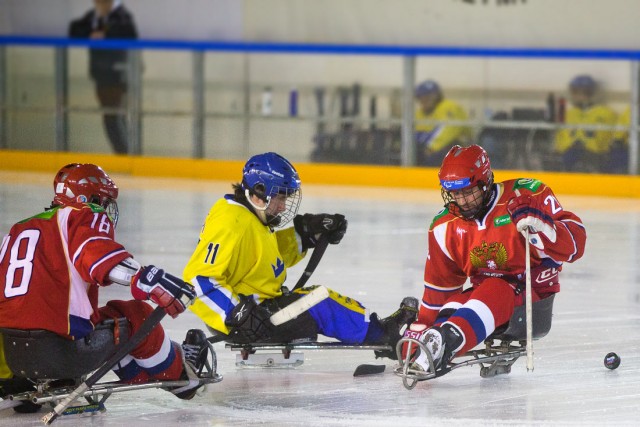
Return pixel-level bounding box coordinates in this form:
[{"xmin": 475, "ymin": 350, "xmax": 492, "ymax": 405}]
[{"xmin": 293, "ymin": 214, "xmax": 347, "ymax": 250}]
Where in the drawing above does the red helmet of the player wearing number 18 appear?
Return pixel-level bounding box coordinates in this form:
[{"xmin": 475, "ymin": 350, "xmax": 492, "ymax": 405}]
[{"xmin": 52, "ymin": 163, "xmax": 118, "ymax": 225}]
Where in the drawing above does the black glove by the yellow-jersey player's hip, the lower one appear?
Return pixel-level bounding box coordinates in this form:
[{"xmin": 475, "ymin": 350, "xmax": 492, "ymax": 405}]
[{"xmin": 224, "ymin": 295, "xmax": 274, "ymax": 344}]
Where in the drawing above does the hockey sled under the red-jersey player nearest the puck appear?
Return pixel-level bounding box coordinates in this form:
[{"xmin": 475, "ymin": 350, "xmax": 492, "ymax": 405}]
[{"xmin": 394, "ymin": 295, "xmax": 555, "ymax": 390}]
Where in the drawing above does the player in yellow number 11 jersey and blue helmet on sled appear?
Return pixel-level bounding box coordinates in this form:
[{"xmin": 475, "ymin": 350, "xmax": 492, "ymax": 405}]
[{"xmin": 184, "ymin": 153, "xmax": 418, "ymax": 357}]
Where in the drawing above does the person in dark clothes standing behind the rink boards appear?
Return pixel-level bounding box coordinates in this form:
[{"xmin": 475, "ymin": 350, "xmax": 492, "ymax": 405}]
[{"xmin": 69, "ymin": 0, "xmax": 138, "ymax": 154}]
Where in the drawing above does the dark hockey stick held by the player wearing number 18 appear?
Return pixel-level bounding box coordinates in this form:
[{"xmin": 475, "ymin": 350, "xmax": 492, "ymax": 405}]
[{"xmin": 42, "ymin": 307, "xmax": 166, "ymax": 425}]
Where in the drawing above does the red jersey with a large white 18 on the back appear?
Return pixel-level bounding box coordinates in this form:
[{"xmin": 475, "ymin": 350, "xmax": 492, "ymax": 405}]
[{"xmin": 0, "ymin": 204, "xmax": 131, "ymax": 338}]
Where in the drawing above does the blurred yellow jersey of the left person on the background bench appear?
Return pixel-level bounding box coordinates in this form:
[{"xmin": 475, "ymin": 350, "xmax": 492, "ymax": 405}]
[{"xmin": 415, "ymin": 99, "xmax": 471, "ymax": 152}]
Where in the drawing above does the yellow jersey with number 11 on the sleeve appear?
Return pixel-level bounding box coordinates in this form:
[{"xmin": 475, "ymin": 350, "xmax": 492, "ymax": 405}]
[{"xmin": 183, "ymin": 195, "xmax": 306, "ymax": 334}]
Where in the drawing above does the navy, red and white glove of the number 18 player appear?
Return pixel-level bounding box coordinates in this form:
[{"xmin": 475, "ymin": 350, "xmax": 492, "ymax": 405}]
[{"xmin": 131, "ymin": 265, "xmax": 196, "ymax": 318}]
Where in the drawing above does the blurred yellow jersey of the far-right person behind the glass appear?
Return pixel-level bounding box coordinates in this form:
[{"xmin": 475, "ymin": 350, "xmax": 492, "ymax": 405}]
[{"xmin": 554, "ymin": 105, "xmax": 617, "ymax": 153}]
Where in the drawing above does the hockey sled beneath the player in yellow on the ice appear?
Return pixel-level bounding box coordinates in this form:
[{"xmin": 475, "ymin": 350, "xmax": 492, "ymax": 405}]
[{"xmin": 226, "ymin": 341, "xmax": 392, "ymax": 368}]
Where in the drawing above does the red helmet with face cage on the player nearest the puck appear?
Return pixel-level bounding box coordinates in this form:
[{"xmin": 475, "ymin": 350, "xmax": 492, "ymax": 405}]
[{"xmin": 438, "ymin": 145, "xmax": 493, "ymax": 219}]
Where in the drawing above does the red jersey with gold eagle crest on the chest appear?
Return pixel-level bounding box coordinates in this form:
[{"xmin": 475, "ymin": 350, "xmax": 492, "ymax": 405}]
[{"xmin": 418, "ymin": 178, "xmax": 587, "ymax": 325}]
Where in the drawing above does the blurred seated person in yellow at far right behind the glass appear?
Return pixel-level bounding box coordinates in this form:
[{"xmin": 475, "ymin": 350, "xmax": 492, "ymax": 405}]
[{"xmin": 554, "ymin": 75, "xmax": 616, "ymax": 172}]
